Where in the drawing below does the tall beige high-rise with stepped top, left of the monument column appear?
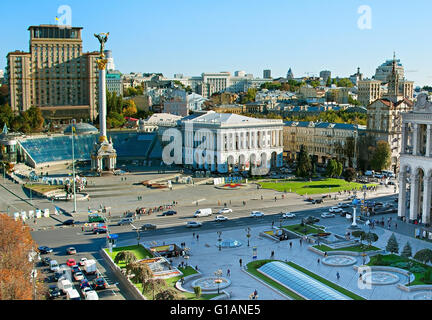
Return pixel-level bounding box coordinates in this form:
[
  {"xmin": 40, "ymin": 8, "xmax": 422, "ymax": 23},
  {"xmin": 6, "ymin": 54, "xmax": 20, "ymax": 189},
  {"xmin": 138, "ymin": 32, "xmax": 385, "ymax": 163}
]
[{"xmin": 6, "ymin": 25, "xmax": 99, "ymax": 120}]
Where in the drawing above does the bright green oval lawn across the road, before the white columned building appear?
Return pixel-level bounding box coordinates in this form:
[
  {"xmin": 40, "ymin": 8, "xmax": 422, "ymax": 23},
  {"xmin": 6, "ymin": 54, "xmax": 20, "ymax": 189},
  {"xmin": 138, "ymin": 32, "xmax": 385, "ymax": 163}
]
[{"xmin": 258, "ymin": 179, "xmax": 372, "ymax": 195}]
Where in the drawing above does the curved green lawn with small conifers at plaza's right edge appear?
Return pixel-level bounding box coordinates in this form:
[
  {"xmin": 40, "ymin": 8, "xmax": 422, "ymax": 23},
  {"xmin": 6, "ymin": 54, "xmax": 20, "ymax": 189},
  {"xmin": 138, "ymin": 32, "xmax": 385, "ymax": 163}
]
[{"xmin": 367, "ymin": 254, "xmax": 432, "ymax": 286}]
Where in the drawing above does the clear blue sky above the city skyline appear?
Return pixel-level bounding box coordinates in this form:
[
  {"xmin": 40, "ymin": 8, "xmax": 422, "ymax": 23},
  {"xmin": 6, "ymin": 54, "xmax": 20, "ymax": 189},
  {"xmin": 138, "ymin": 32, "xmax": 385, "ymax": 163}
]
[{"xmin": 0, "ymin": 0, "xmax": 432, "ymax": 86}]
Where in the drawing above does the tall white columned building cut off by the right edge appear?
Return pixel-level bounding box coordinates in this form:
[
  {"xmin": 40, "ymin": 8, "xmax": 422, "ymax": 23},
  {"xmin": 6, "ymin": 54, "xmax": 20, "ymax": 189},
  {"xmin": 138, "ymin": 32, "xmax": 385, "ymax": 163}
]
[{"xmin": 398, "ymin": 93, "xmax": 432, "ymax": 225}]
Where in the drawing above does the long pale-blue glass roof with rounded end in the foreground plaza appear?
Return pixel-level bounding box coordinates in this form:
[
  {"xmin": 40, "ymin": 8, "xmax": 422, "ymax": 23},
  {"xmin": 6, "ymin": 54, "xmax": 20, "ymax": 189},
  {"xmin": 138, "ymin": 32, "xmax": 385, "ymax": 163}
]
[{"xmin": 258, "ymin": 261, "xmax": 350, "ymax": 300}]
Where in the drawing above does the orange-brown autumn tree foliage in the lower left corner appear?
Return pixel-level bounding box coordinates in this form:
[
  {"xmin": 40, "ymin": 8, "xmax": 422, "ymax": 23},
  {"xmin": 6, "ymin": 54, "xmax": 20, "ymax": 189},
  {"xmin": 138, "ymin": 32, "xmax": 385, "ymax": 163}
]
[{"xmin": 0, "ymin": 214, "xmax": 43, "ymax": 300}]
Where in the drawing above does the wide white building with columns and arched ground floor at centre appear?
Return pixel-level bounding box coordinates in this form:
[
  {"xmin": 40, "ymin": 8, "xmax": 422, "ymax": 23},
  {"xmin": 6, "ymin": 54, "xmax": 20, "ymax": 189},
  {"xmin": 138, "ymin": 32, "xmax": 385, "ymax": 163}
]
[{"xmin": 180, "ymin": 111, "xmax": 283, "ymax": 175}]
